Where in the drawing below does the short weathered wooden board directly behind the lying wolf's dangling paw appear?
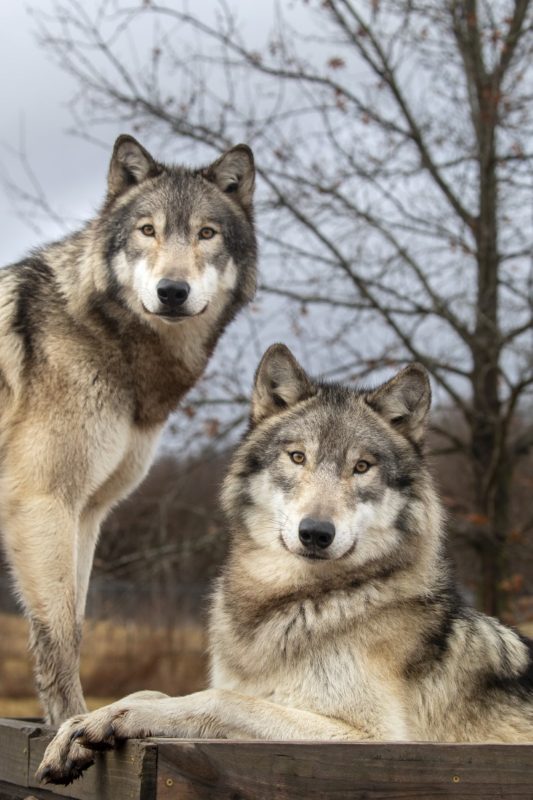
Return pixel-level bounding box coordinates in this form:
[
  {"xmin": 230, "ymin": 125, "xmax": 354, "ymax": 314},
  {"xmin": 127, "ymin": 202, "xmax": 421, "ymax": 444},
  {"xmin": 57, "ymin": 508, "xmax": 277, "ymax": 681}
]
[{"xmin": 28, "ymin": 733, "xmax": 157, "ymax": 800}]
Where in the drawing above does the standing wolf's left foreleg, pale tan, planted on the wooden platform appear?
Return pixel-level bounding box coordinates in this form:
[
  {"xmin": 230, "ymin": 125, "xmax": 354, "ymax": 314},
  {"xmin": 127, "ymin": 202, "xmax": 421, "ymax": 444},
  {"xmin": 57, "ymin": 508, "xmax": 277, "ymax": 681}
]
[{"xmin": 2, "ymin": 495, "xmax": 86, "ymax": 725}]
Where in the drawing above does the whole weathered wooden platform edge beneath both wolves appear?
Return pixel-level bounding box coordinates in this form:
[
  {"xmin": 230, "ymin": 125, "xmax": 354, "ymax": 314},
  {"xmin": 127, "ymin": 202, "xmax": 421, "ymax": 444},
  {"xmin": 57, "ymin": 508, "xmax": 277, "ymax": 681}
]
[{"xmin": 0, "ymin": 719, "xmax": 533, "ymax": 800}]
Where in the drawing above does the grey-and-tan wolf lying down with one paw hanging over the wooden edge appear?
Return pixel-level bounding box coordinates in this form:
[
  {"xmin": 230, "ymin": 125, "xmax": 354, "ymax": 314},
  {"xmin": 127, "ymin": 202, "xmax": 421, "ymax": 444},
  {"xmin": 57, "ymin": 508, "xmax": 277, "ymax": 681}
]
[{"xmin": 40, "ymin": 345, "xmax": 533, "ymax": 782}]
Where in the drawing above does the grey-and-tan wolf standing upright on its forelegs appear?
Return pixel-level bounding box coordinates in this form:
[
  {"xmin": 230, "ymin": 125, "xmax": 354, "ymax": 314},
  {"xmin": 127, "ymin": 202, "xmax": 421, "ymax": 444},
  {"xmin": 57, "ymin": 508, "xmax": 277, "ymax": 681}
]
[{"xmin": 0, "ymin": 136, "xmax": 256, "ymax": 724}]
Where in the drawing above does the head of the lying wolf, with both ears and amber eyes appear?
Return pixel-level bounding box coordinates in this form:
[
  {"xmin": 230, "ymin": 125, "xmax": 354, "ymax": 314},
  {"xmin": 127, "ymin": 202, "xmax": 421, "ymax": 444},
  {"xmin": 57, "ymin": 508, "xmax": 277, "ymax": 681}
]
[{"xmin": 222, "ymin": 344, "xmax": 438, "ymax": 571}]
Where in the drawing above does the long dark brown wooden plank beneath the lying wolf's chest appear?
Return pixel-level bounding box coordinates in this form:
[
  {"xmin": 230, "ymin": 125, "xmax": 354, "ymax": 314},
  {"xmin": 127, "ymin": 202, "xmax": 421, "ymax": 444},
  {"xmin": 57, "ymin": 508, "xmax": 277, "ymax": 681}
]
[{"xmin": 155, "ymin": 739, "xmax": 533, "ymax": 800}]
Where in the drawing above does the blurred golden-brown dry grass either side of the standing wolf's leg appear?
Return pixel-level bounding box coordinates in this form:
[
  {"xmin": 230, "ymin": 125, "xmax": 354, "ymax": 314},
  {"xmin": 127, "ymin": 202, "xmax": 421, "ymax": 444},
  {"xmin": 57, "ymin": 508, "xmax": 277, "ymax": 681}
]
[{"xmin": 0, "ymin": 614, "xmax": 207, "ymax": 717}]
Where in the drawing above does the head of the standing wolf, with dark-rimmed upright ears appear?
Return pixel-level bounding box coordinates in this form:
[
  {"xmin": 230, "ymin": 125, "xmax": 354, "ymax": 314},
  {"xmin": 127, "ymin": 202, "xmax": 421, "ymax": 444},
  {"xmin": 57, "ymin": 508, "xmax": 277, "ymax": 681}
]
[{"xmin": 100, "ymin": 135, "xmax": 256, "ymax": 325}]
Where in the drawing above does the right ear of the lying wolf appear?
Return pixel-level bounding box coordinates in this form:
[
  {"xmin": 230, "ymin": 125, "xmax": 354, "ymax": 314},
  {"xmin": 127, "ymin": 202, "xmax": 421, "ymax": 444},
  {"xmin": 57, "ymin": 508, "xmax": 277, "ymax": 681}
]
[{"xmin": 366, "ymin": 364, "xmax": 431, "ymax": 442}]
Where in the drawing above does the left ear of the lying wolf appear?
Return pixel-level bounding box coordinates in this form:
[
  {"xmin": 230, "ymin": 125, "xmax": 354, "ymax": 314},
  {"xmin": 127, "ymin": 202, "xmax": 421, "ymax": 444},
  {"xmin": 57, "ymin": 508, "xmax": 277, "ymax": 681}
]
[{"xmin": 251, "ymin": 344, "xmax": 316, "ymax": 424}]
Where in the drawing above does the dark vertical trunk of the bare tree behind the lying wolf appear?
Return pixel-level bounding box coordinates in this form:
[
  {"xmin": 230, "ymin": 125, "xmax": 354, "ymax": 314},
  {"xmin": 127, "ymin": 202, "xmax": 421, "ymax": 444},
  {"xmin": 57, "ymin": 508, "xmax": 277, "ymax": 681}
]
[{"xmin": 471, "ymin": 28, "xmax": 502, "ymax": 615}]
